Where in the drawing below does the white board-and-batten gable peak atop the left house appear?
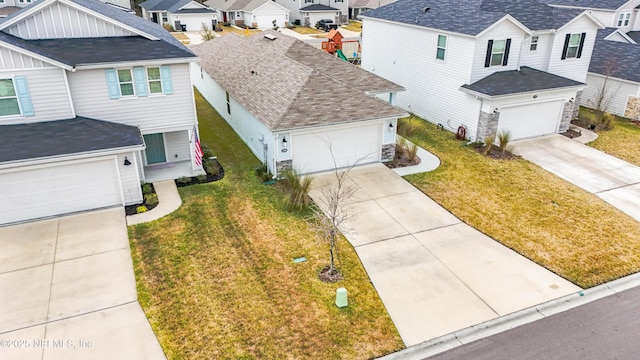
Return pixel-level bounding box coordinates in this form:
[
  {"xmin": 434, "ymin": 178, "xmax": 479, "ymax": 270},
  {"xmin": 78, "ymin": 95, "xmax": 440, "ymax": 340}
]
[{"xmin": 4, "ymin": 3, "xmax": 137, "ymax": 40}]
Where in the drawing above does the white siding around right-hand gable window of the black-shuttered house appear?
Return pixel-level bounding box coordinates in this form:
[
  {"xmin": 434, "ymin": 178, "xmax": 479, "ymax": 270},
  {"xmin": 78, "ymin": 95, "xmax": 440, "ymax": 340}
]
[{"xmin": 549, "ymin": 16, "xmax": 597, "ymax": 82}]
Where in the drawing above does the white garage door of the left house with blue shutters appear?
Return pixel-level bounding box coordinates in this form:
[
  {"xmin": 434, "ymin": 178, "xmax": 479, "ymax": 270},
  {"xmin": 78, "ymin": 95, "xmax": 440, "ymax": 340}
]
[{"xmin": 0, "ymin": 160, "xmax": 122, "ymax": 224}]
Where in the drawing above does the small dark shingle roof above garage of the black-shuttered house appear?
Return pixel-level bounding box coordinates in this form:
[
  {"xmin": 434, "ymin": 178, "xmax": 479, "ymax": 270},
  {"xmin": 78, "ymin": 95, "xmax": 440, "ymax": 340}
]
[{"xmin": 462, "ymin": 66, "xmax": 584, "ymax": 97}]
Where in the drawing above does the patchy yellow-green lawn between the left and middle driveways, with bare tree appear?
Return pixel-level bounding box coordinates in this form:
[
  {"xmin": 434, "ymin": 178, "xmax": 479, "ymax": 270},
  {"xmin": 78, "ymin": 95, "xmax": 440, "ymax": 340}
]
[{"xmin": 129, "ymin": 89, "xmax": 403, "ymax": 359}]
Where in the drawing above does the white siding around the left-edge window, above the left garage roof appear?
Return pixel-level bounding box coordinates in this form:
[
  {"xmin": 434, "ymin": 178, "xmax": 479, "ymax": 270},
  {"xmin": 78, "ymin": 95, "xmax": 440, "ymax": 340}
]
[{"xmin": 0, "ymin": 67, "xmax": 74, "ymax": 125}]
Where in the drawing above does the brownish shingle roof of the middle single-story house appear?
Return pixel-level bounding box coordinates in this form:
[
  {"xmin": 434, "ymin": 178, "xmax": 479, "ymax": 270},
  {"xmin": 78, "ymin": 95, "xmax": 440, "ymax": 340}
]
[{"xmin": 193, "ymin": 31, "xmax": 405, "ymax": 130}]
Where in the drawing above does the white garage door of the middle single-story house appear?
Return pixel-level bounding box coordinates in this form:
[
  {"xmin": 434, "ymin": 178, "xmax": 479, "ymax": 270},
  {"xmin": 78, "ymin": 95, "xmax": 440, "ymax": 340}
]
[{"xmin": 291, "ymin": 124, "xmax": 382, "ymax": 173}]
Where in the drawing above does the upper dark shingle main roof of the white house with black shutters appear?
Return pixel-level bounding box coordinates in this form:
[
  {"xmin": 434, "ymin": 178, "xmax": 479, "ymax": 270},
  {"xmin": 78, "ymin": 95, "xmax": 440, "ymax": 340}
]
[{"xmin": 363, "ymin": 0, "xmax": 592, "ymax": 35}]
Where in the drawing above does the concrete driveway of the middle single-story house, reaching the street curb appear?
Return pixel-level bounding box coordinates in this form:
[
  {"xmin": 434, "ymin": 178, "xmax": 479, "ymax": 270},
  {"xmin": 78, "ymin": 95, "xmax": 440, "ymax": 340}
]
[{"xmin": 309, "ymin": 164, "xmax": 580, "ymax": 346}]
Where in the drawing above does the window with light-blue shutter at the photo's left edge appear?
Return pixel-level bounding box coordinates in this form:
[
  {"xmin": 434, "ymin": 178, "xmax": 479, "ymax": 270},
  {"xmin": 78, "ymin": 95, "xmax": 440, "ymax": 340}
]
[{"xmin": 0, "ymin": 76, "xmax": 35, "ymax": 116}]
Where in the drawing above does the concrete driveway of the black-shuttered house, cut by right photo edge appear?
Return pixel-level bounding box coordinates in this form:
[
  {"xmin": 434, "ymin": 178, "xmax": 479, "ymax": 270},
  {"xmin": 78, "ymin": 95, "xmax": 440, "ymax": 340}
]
[{"xmin": 509, "ymin": 135, "xmax": 640, "ymax": 221}]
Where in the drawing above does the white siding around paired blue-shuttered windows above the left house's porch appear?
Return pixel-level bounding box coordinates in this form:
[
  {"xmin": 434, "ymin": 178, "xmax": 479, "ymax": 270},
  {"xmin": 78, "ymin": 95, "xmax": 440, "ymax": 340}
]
[{"xmin": 69, "ymin": 64, "xmax": 196, "ymax": 134}]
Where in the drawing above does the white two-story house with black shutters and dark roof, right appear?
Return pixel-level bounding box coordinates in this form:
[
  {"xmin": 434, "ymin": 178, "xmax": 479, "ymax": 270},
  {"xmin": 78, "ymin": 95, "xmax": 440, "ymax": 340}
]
[{"xmin": 361, "ymin": 0, "xmax": 603, "ymax": 141}]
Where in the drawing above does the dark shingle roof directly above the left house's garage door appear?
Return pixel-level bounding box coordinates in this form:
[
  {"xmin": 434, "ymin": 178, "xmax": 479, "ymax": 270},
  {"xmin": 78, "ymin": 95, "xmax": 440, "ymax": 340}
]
[{"xmin": 0, "ymin": 116, "xmax": 143, "ymax": 162}]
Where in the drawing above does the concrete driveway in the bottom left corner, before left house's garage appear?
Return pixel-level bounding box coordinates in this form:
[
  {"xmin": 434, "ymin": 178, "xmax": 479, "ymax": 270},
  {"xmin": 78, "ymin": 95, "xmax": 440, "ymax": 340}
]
[{"xmin": 0, "ymin": 208, "xmax": 165, "ymax": 360}]
